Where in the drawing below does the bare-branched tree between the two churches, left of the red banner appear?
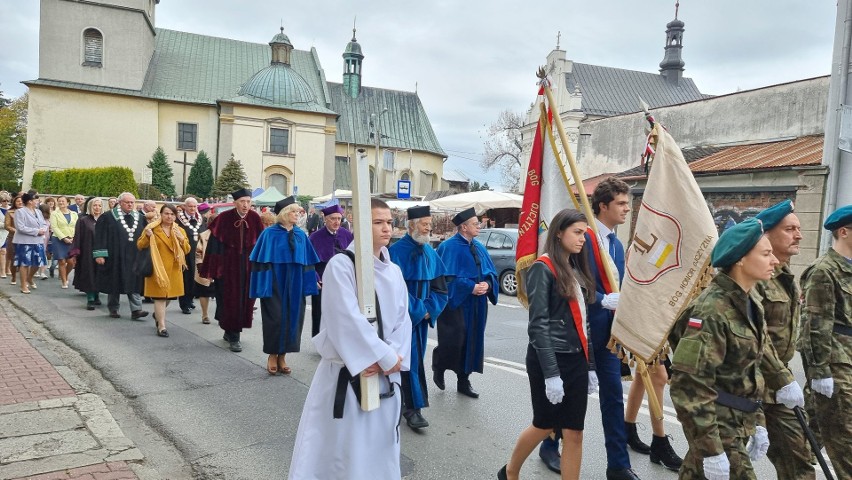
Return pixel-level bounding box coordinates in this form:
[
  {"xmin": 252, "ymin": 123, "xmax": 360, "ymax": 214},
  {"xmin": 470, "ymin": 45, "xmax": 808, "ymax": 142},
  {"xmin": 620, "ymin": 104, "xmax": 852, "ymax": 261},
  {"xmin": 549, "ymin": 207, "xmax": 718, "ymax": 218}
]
[{"xmin": 479, "ymin": 110, "xmax": 524, "ymax": 191}]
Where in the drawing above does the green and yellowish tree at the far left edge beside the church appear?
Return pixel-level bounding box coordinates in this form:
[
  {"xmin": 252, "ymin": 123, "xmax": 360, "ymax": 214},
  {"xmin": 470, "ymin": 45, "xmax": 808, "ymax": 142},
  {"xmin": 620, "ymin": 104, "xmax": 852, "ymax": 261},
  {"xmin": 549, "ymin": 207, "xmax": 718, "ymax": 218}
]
[{"xmin": 0, "ymin": 92, "xmax": 29, "ymax": 191}]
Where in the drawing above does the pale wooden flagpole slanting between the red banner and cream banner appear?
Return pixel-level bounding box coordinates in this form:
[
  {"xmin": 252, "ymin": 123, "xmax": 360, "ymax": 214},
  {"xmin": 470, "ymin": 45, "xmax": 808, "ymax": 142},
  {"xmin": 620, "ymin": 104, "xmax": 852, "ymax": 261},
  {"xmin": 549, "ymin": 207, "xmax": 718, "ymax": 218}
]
[{"xmin": 538, "ymin": 68, "xmax": 663, "ymax": 420}]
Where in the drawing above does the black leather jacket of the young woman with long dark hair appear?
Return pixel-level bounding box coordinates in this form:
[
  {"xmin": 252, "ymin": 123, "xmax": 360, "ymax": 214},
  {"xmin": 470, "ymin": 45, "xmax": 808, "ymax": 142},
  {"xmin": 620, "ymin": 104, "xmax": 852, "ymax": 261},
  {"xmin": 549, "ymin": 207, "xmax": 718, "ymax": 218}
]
[{"xmin": 524, "ymin": 262, "xmax": 594, "ymax": 378}]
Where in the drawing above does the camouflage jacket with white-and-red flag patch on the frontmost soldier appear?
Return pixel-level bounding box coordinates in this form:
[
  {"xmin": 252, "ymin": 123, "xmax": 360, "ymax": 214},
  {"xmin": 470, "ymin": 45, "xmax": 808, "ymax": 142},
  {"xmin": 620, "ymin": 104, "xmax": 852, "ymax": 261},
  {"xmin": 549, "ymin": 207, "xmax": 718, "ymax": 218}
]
[{"xmin": 669, "ymin": 273, "xmax": 793, "ymax": 458}]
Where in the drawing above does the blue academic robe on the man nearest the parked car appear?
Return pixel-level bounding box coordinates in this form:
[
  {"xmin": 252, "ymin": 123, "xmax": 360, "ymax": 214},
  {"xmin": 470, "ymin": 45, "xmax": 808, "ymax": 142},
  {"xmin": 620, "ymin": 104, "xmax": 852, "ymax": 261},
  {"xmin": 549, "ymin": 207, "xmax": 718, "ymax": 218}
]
[{"xmin": 432, "ymin": 233, "xmax": 498, "ymax": 376}]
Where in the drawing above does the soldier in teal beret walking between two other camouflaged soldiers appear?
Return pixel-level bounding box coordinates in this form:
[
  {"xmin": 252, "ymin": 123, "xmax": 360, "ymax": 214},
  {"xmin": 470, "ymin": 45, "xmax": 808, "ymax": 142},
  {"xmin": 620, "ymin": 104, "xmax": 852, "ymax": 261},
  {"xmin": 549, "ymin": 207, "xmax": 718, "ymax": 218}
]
[{"xmin": 755, "ymin": 200, "xmax": 816, "ymax": 480}]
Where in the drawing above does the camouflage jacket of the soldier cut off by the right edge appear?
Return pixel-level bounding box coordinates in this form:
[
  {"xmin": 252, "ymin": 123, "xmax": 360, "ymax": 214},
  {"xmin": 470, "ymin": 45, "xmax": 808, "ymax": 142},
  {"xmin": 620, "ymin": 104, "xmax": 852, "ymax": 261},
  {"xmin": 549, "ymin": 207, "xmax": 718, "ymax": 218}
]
[{"xmin": 799, "ymin": 248, "xmax": 852, "ymax": 378}]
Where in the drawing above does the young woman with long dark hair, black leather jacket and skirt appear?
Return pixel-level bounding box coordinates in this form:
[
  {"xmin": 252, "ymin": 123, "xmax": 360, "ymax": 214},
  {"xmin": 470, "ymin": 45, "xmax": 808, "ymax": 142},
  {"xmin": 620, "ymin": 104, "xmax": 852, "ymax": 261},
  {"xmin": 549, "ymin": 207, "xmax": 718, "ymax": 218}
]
[{"xmin": 497, "ymin": 209, "xmax": 597, "ymax": 480}]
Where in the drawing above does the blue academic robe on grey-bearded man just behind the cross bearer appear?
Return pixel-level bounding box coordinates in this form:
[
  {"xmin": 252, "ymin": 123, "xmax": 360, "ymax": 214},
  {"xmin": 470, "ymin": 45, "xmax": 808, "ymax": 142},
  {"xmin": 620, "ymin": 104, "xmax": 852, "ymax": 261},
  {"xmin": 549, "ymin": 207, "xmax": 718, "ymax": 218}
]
[{"xmin": 388, "ymin": 234, "xmax": 447, "ymax": 409}]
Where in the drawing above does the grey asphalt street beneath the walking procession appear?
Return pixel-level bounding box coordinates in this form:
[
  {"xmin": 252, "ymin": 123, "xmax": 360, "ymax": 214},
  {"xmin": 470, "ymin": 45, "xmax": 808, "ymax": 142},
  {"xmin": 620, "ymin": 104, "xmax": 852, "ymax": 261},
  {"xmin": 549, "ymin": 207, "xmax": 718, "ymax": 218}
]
[{"xmin": 0, "ymin": 279, "xmax": 836, "ymax": 480}]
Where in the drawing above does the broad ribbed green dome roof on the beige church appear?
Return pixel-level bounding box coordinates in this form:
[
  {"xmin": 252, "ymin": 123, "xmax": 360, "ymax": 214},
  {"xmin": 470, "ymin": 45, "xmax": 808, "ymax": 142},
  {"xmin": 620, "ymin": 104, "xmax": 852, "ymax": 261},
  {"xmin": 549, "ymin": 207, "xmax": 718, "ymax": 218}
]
[{"xmin": 239, "ymin": 63, "xmax": 319, "ymax": 106}]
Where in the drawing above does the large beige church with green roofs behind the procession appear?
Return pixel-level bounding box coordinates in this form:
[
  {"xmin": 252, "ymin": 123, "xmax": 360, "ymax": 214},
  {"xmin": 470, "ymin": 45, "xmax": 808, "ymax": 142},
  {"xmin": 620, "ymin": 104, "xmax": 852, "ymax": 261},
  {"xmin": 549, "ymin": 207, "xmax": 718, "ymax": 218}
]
[{"xmin": 24, "ymin": 0, "xmax": 446, "ymax": 196}]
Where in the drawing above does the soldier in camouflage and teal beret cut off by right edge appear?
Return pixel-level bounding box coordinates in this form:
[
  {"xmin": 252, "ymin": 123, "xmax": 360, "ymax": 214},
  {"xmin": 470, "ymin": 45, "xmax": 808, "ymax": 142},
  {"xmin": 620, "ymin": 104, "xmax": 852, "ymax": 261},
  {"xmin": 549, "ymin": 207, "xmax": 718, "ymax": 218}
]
[{"xmin": 800, "ymin": 205, "xmax": 852, "ymax": 478}]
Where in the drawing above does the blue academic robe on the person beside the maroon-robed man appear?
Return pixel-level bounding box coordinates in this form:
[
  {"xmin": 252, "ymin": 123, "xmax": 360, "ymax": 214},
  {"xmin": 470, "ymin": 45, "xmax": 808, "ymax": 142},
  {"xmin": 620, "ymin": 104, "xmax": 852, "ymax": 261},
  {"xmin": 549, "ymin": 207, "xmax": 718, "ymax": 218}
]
[{"xmin": 249, "ymin": 224, "xmax": 319, "ymax": 354}]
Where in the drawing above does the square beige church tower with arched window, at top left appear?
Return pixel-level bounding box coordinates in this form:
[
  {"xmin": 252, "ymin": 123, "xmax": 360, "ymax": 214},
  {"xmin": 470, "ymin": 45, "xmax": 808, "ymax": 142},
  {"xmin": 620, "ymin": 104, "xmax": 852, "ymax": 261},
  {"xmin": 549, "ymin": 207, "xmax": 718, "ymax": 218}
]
[{"xmin": 39, "ymin": 0, "xmax": 159, "ymax": 90}]
